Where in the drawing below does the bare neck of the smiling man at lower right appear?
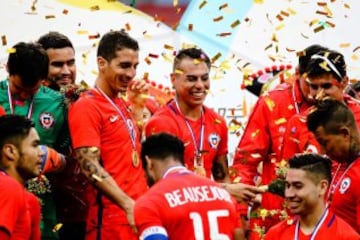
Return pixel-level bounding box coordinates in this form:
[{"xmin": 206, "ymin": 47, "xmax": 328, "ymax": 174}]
[{"xmin": 299, "ymin": 203, "xmax": 326, "ymax": 234}]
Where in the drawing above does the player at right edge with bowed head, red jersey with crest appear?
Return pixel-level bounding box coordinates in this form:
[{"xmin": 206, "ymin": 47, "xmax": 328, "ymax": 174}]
[{"xmin": 307, "ymin": 99, "xmax": 360, "ymax": 233}]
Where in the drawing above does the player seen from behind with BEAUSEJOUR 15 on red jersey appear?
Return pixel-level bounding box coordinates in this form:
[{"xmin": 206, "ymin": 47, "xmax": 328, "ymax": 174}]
[{"xmin": 134, "ymin": 133, "xmax": 242, "ymax": 240}]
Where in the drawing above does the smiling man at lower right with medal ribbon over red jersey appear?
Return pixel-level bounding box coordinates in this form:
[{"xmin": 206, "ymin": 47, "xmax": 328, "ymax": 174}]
[{"xmin": 265, "ymin": 154, "xmax": 360, "ymax": 240}]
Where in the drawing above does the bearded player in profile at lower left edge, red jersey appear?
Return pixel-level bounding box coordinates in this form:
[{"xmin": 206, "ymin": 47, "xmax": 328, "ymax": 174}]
[{"xmin": 0, "ymin": 115, "xmax": 44, "ymax": 240}]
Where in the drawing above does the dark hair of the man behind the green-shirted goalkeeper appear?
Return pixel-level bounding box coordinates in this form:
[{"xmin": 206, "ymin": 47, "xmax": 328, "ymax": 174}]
[{"xmin": 37, "ymin": 31, "xmax": 75, "ymax": 50}]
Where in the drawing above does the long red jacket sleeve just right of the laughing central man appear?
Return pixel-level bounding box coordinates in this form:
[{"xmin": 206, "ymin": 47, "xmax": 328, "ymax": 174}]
[{"xmin": 233, "ymin": 97, "xmax": 271, "ymax": 185}]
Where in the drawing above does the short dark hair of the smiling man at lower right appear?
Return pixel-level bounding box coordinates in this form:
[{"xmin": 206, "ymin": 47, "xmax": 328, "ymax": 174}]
[{"xmin": 288, "ymin": 153, "xmax": 331, "ymax": 183}]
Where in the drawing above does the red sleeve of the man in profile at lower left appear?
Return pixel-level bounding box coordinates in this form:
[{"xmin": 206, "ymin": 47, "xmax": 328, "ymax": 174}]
[{"xmin": 0, "ymin": 177, "xmax": 25, "ymax": 235}]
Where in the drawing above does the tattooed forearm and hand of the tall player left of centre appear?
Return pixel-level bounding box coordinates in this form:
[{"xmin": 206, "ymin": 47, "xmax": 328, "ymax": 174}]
[{"xmin": 75, "ymin": 147, "xmax": 135, "ymax": 229}]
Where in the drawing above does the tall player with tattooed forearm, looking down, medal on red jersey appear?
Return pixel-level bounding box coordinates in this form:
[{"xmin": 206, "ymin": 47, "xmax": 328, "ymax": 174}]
[{"xmin": 69, "ymin": 31, "xmax": 148, "ymax": 240}]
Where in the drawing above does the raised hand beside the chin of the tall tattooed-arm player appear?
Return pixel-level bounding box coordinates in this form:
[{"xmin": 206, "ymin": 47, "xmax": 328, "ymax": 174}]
[{"xmin": 127, "ymin": 80, "xmax": 149, "ymax": 107}]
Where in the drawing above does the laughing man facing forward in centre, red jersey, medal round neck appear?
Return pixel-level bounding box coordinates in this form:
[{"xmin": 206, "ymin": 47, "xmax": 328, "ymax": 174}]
[{"xmin": 145, "ymin": 48, "xmax": 230, "ymax": 182}]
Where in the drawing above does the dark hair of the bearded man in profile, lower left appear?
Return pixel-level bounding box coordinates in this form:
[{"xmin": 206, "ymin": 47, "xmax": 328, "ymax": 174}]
[{"xmin": 0, "ymin": 114, "xmax": 34, "ymax": 149}]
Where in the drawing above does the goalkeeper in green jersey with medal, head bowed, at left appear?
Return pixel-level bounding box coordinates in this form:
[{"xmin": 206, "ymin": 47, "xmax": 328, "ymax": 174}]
[{"xmin": 0, "ymin": 42, "xmax": 70, "ymax": 239}]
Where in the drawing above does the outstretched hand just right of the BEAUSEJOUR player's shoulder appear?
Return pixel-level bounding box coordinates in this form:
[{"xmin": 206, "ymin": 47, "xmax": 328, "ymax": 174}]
[{"xmin": 223, "ymin": 183, "xmax": 264, "ymax": 203}]
